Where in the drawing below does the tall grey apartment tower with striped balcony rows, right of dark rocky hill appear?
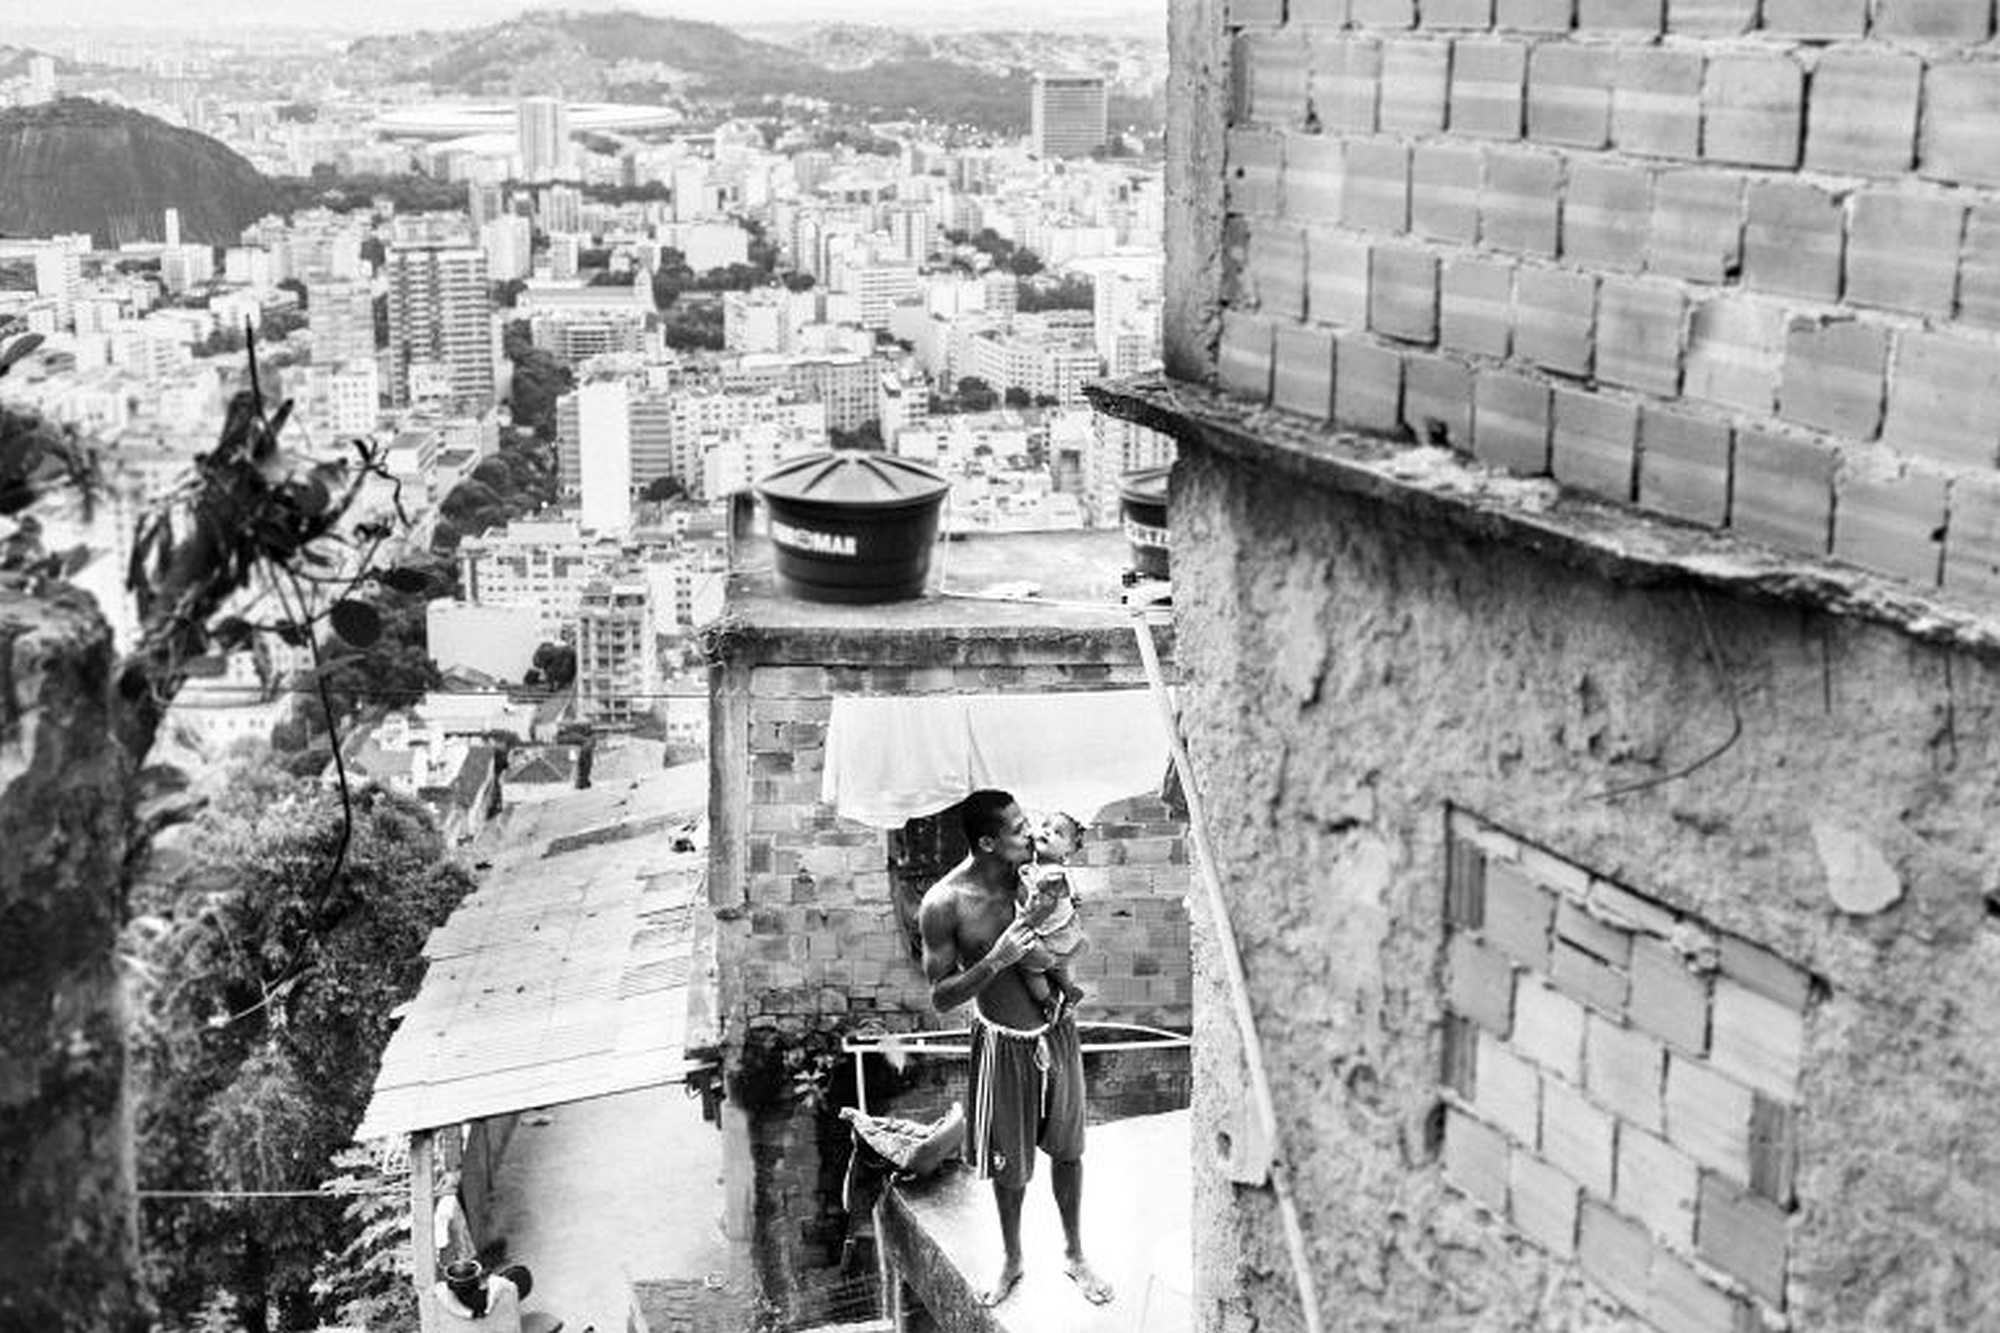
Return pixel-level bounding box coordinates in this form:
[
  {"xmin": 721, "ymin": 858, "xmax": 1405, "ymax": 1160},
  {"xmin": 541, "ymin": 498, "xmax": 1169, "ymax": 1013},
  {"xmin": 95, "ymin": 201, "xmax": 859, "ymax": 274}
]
[{"xmin": 384, "ymin": 244, "xmax": 494, "ymax": 410}]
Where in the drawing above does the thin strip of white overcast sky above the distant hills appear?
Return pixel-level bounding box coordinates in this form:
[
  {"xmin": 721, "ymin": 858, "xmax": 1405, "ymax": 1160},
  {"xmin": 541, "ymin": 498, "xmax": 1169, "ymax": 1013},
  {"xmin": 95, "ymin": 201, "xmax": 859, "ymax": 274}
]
[{"xmin": 39, "ymin": 0, "xmax": 1166, "ymax": 42}]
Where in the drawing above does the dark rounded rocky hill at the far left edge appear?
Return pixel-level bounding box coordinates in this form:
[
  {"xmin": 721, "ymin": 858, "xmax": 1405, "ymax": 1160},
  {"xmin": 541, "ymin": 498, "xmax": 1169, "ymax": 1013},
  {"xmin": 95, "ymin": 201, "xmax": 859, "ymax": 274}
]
[{"xmin": 0, "ymin": 98, "xmax": 276, "ymax": 246}]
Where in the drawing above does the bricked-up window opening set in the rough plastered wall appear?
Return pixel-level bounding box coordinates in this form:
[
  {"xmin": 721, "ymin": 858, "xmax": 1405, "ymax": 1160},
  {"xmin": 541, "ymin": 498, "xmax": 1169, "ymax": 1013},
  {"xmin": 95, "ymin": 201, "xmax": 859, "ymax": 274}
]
[{"xmin": 1442, "ymin": 811, "xmax": 1812, "ymax": 1333}]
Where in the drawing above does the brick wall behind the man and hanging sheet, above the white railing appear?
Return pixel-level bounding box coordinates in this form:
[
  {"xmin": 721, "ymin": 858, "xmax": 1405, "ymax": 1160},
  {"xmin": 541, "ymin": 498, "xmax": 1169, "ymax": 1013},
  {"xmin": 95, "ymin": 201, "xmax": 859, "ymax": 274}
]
[{"xmin": 718, "ymin": 662, "xmax": 1190, "ymax": 1031}]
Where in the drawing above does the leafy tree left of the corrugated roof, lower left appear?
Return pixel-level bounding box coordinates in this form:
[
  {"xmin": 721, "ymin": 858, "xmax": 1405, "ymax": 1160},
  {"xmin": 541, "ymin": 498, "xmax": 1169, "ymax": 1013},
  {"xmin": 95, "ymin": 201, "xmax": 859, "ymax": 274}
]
[{"xmin": 130, "ymin": 761, "xmax": 472, "ymax": 1333}]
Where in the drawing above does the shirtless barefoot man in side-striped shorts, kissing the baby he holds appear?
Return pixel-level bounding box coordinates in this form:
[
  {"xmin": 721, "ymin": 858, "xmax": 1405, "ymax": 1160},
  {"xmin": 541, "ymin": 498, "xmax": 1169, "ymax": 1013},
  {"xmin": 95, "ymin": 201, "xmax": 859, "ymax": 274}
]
[{"xmin": 918, "ymin": 791, "xmax": 1112, "ymax": 1305}]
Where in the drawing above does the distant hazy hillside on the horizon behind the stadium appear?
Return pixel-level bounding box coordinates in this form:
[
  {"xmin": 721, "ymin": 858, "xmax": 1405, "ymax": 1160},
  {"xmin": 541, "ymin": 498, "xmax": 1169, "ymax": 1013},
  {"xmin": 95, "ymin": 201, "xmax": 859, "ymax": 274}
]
[{"xmin": 348, "ymin": 10, "xmax": 1152, "ymax": 132}]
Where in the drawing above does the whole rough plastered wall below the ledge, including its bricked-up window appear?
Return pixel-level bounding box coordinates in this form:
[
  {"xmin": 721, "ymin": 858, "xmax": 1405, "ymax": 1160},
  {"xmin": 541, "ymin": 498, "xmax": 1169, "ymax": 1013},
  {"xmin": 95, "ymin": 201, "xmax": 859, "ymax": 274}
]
[{"xmin": 1174, "ymin": 440, "xmax": 2000, "ymax": 1333}]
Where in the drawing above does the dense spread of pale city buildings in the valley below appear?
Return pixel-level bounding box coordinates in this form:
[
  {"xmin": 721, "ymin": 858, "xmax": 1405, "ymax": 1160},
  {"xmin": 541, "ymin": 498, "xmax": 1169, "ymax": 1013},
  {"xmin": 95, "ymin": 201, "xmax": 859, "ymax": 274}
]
[{"xmin": 0, "ymin": 80, "xmax": 1168, "ymax": 788}]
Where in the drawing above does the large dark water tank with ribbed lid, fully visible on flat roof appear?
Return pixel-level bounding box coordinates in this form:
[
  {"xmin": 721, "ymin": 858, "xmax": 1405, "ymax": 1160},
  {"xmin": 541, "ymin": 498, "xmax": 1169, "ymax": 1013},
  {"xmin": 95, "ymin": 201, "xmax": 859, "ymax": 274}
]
[{"xmin": 756, "ymin": 448, "xmax": 952, "ymax": 602}]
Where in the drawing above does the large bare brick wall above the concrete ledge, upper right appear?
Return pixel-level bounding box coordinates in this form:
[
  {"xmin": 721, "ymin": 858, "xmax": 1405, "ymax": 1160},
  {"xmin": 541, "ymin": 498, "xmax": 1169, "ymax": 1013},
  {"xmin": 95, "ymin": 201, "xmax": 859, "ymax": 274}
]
[{"xmin": 1216, "ymin": 0, "xmax": 2000, "ymax": 598}]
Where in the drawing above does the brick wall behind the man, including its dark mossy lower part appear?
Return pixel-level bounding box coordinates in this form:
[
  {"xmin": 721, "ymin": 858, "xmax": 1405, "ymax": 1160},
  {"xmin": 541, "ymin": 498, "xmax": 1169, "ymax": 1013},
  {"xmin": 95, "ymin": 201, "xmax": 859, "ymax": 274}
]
[{"xmin": 710, "ymin": 648, "xmax": 1194, "ymax": 1305}]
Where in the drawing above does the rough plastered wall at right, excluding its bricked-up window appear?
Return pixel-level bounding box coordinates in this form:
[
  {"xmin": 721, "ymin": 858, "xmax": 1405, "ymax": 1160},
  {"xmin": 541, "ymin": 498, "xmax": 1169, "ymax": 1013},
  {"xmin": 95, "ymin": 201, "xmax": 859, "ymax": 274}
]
[{"xmin": 1174, "ymin": 450, "xmax": 2000, "ymax": 1333}]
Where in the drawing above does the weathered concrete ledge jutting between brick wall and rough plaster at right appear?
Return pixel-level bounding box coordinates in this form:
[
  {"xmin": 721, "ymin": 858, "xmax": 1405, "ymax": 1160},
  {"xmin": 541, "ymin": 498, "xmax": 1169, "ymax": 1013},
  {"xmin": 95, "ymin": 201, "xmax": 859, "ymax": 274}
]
[{"xmin": 1084, "ymin": 376, "xmax": 2000, "ymax": 656}]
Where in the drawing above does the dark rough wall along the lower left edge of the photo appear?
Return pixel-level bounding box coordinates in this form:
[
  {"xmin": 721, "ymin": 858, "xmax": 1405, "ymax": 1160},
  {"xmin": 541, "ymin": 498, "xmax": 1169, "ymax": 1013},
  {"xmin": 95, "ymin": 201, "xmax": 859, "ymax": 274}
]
[{"xmin": 0, "ymin": 590, "xmax": 142, "ymax": 1329}]
